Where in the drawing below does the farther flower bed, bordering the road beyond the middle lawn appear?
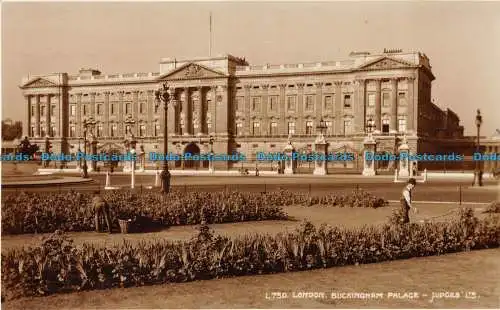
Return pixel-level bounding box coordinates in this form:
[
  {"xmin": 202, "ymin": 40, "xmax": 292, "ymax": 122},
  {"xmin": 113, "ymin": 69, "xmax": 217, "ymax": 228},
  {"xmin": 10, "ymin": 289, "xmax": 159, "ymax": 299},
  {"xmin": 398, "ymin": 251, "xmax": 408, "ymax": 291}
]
[{"xmin": 2, "ymin": 191, "xmax": 387, "ymax": 234}]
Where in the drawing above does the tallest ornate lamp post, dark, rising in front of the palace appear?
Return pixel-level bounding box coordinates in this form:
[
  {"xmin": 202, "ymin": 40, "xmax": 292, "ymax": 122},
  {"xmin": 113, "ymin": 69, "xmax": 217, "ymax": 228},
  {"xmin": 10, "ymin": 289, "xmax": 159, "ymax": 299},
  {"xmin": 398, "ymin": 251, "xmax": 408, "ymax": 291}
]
[{"xmin": 155, "ymin": 83, "xmax": 175, "ymax": 194}]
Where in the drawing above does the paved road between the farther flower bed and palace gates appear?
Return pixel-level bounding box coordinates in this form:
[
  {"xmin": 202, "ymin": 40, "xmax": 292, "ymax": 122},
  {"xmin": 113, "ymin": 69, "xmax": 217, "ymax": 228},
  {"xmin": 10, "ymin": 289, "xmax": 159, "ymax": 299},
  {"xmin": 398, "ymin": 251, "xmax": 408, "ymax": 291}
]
[{"xmin": 2, "ymin": 175, "xmax": 500, "ymax": 202}]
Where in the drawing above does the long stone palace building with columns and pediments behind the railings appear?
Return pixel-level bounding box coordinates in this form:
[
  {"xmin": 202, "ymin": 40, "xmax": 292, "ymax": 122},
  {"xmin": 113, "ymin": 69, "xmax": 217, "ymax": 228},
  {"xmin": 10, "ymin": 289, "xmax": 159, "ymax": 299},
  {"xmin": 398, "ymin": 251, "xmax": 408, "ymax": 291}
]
[{"xmin": 20, "ymin": 50, "xmax": 463, "ymax": 170}]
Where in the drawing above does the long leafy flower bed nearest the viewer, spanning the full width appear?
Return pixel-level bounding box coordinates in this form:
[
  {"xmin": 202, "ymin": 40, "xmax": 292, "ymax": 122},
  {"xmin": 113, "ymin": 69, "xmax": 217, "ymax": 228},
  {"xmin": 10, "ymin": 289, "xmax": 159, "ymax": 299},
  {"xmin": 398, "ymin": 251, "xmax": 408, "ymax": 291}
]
[{"xmin": 2, "ymin": 209, "xmax": 500, "ymax": 299}]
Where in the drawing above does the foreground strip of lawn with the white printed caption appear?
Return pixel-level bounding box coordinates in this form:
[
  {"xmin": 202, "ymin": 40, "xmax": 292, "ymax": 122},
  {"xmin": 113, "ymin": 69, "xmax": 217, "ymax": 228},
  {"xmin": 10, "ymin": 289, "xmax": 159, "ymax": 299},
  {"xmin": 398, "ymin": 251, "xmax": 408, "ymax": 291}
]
[{"xmin": 2, "ymin": 249, "xmax": 500, "ymax": 309}]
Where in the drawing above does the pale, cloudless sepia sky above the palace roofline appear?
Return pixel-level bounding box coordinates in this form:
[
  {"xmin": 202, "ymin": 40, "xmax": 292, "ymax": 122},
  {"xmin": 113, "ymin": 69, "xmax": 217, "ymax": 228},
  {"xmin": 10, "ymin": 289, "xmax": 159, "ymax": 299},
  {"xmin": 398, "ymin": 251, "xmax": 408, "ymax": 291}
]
[{"xmin": 2, "ymin": 1, "xmax": 500, "ymax": 135}]
